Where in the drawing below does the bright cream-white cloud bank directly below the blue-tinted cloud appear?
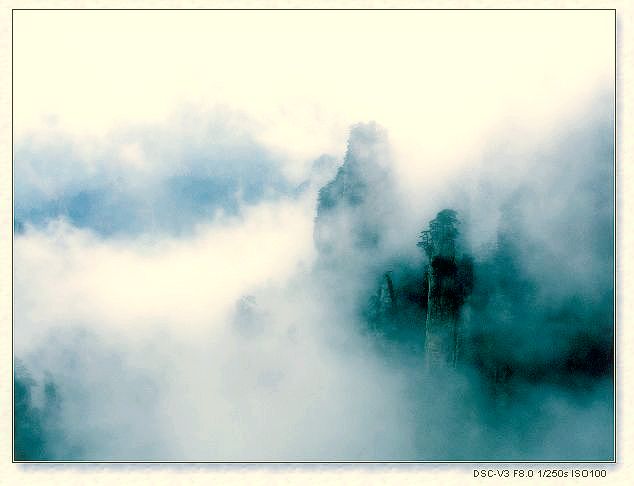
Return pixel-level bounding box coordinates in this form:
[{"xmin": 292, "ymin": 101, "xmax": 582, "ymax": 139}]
[{"xmin": 14, "ymin": 192, "xmax": 313, "ymax": 350}]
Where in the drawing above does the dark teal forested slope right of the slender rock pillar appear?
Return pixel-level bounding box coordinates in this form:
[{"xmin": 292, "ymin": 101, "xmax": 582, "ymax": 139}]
[{"xmin": 466, "ymin": 228, "xmax": 613, "ymax": 394}]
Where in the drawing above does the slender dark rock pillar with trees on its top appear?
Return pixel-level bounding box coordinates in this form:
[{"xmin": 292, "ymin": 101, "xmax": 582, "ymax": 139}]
[{"xmin": 419, "ymin": 209, "xmax": 473, "ymax": 367}]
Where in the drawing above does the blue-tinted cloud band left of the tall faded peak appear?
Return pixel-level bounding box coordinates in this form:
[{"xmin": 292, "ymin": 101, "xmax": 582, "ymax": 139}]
[{"xmin": 15, "ymin": 110, "xmax": 296, "ymax": 236}]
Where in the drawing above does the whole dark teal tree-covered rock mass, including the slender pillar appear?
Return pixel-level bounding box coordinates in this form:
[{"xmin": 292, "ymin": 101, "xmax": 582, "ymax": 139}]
[{"xmin": 364, "ymin": 201, "xmax": 613, "ymax": 394}]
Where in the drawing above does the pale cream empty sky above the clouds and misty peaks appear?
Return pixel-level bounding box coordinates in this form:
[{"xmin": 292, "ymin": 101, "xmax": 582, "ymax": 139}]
[{"xmin": 14, "ymin": 11, "xmax": 614, "ymax": 177}]
